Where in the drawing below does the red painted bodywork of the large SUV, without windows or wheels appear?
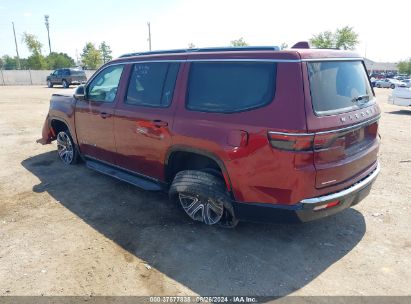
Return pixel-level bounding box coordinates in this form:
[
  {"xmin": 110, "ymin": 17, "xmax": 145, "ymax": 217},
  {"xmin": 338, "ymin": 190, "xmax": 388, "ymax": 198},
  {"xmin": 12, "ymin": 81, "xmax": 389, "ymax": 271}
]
[{"xmin": 43, "ymin": 49, "xmax": 380, "ymax": 205}]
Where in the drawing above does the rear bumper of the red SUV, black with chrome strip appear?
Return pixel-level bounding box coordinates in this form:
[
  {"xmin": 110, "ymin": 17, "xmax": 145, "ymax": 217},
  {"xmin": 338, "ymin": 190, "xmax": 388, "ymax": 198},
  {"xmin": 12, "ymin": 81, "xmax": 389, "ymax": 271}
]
[{"xmin": 233, "ymin": 164, "xmax": 380, "ymax": 222}]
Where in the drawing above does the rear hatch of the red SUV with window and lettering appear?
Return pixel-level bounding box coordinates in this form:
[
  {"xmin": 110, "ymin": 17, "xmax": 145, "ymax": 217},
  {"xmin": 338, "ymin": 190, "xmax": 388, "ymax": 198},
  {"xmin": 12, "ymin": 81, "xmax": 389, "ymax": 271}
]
[{"xmin": 306, "ymin": 59, "xmax": 380, "ymax": 188}]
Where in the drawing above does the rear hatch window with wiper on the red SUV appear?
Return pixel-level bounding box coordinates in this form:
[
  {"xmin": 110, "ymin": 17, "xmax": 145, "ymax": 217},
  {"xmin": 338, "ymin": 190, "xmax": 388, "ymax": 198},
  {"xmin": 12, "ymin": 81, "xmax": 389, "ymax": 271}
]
[{"xmin": 308, "ymin": 61, "xmax": 373, "ymax": 115}]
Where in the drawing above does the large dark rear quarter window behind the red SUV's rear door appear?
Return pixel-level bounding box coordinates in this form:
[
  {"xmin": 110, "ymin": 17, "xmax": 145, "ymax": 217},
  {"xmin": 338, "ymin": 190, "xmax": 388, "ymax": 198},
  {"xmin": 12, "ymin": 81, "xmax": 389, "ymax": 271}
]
[{"xmin": 187, "ymin": 62, "xmax": 277, "ymax": 113}]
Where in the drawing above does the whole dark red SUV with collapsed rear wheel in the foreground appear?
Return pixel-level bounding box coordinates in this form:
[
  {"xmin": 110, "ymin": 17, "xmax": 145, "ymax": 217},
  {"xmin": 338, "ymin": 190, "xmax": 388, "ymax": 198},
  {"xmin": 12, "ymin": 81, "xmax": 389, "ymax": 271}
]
[{"xmin": 38, "ymin": 47, "xmax": 380, "ymax": 227}]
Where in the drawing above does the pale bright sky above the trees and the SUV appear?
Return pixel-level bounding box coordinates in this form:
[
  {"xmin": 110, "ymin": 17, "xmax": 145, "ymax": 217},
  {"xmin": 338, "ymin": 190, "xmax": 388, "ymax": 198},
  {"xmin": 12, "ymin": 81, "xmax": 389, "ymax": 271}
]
[{"xmin": 0, "ymin": 0, "xmax": 411, "ymax": 62}]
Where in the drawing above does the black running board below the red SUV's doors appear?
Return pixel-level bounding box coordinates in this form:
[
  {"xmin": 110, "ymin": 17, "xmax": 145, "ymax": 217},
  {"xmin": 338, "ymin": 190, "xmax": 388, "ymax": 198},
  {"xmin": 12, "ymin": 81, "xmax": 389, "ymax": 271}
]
[{"xmin": 86, "ymin": 160, "xmax": 164, "ymax": 191}]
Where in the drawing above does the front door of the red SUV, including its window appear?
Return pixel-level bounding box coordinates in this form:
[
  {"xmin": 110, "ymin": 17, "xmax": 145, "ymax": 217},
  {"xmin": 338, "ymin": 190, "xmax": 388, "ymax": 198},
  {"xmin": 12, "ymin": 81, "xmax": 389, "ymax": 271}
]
[{"xmin": 75, "ymin": 65, "xmax": 124, "ymax": 163}]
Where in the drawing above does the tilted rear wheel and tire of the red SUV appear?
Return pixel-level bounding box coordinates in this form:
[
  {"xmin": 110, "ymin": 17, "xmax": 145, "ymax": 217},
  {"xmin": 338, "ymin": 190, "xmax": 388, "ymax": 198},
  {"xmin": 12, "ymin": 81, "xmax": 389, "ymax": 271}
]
[{"xmin": 169, "ymin": 170, "xmax": 238, "ymax": 228}]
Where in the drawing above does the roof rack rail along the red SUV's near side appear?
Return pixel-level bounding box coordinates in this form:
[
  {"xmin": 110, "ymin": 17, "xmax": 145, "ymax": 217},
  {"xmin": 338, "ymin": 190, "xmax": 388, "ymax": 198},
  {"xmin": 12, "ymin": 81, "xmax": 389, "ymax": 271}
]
[{"xmin": 119, "ymin": 46, "xmax": 280, "ymax": 58}]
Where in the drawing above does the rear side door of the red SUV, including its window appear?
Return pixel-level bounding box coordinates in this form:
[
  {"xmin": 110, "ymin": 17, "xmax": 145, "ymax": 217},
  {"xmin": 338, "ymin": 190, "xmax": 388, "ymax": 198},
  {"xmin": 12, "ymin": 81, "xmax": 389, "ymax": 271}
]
[{"xmin": 114, "ymin": 62, "xmax": 180, "ymax": 180}]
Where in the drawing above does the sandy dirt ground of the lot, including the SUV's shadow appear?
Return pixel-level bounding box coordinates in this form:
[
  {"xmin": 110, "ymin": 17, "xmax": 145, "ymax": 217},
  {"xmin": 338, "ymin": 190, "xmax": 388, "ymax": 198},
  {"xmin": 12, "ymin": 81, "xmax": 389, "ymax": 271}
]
[{"xmin": 0, "ymin": 86, "xmax": 411, "ymax": 296}]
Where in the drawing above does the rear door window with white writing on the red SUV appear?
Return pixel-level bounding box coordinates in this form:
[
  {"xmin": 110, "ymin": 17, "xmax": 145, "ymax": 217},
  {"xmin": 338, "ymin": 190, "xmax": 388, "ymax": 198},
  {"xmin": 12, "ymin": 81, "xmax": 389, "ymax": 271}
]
[{"xmin": 125, "ymin": 62, "xmax": 180, "ymax": 107}]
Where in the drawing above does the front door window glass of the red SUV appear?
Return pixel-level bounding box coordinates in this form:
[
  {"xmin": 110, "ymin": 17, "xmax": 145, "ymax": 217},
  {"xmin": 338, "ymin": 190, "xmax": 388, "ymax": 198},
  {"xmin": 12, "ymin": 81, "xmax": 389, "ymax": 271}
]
[{"xmin": 87, "ymin": 65, "xmax": 124, "ymax": 102}]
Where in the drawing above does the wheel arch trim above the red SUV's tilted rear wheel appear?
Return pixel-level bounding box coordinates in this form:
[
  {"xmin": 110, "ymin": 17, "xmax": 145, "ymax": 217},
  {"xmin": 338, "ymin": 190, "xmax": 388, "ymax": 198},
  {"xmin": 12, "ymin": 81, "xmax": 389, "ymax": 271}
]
[{"xmin": 164, "ymin": 145, "xmax": 233, "ymax": 192}]
